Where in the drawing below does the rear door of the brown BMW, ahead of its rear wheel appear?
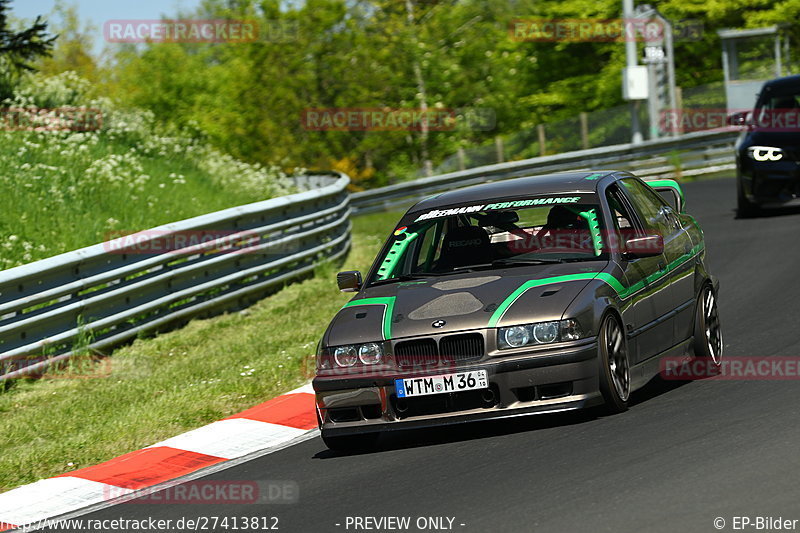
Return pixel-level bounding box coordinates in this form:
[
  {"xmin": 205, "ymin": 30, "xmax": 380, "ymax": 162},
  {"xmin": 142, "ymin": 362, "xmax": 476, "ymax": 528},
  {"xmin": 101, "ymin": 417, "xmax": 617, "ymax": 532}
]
[{"xmin": 621, "ymin": 178, "xmax": 694, "ymax": 349}]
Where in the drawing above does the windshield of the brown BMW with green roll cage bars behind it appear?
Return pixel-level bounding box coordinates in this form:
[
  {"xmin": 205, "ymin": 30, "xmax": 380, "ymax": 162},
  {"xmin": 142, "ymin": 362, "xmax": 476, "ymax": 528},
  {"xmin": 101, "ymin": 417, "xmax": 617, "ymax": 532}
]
[{"xmin": 371, "ymin": 201, "xmax": 607, "ymax": 283}]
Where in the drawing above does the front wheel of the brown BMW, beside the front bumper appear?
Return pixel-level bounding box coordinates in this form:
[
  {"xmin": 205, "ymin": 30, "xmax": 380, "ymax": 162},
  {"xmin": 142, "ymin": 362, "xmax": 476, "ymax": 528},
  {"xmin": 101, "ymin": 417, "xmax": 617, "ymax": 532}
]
[{"xmin": 598, "ymin": 314, "xmax": 631, "ymax": 414}]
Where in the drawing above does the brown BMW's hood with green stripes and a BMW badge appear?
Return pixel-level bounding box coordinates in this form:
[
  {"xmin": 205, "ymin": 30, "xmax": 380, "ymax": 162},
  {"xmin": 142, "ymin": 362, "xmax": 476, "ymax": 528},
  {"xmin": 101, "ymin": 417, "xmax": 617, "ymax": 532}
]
[{"xmin": 325, "ymin": 261, "xmax": 607, "ymax": 346}]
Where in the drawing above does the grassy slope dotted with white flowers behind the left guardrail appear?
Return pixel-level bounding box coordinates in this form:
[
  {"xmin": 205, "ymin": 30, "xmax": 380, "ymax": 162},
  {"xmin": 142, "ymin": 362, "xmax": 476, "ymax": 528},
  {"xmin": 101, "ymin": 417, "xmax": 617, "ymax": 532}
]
[{"xmin": 0, "ymin": 127, "xmax": 288, "ymax": 270}]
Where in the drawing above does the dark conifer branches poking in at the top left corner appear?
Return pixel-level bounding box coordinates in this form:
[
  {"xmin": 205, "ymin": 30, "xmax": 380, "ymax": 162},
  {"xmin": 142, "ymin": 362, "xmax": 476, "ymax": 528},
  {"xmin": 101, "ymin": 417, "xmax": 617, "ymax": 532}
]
[{"xmin": 0, "ymin": 0, "xmax": 58, "ymax": 100}]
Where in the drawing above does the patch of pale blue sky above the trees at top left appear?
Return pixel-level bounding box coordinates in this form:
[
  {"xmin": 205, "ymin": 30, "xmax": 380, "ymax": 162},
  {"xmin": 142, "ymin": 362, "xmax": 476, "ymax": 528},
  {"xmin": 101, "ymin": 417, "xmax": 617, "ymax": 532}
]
[{"xmin": 11, "ymin": 0, "xmax": 201, "ymax": 52}]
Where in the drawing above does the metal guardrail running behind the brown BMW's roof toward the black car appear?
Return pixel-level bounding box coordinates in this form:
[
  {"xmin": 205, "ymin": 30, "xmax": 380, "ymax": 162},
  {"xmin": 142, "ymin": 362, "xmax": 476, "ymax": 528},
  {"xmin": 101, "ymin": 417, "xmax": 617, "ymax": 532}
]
[{"xmin": 351, "ymin": 131, "xmax": 738, "ymax": 214}]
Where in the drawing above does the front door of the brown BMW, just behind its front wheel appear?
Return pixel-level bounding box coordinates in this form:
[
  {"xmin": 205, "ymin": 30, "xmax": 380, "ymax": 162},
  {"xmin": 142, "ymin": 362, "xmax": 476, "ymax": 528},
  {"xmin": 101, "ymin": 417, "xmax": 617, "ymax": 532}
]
[{"xmin": 607, "ymin": 182, "xmax": 674, "ymax": 365}]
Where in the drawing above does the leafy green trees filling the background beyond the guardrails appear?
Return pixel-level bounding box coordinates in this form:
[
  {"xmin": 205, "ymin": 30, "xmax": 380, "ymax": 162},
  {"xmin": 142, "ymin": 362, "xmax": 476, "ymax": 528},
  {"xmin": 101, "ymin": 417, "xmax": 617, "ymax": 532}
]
[{"xmin": 98, "ymin": 0, "xmax": 800, "ymax": 186}]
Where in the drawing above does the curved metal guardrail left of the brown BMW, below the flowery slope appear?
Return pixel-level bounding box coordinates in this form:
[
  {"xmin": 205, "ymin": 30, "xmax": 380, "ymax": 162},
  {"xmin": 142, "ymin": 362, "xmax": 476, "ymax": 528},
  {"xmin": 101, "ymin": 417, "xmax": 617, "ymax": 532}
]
[{"xmin": 0, "ymin": 173, "xmax": 350, "ymax": 380}]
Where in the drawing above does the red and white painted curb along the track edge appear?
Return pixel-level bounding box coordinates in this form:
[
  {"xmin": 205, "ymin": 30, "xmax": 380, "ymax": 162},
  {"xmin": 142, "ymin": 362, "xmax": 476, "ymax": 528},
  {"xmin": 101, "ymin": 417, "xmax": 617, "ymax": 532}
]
[{"xmin": 0, "ymin": 384, "xmax": 317, "ymax": 531}]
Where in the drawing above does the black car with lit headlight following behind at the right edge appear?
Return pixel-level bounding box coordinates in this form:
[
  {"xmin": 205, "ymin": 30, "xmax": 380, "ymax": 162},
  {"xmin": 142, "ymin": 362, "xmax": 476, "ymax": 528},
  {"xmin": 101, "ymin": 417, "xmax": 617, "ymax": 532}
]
[{"xmin": 731, "ymin": 76, "xmax": 800, "ymax": 217}]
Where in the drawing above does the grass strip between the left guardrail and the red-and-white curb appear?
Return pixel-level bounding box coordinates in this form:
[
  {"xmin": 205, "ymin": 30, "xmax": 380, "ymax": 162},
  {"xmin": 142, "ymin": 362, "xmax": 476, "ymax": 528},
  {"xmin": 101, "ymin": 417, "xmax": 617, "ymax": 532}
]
[{"xmin": 0, "ymin": 213, "xmax": 400, "ymax": 491}]
